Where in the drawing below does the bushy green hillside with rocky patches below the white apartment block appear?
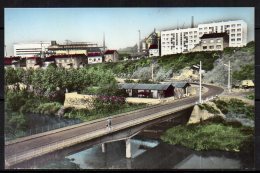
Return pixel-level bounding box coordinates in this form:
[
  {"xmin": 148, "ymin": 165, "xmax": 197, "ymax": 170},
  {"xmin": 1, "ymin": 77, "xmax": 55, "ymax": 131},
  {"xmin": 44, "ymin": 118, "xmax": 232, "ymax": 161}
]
[{"xmin": 87, "ymin": 42, "xmax": 255, "ymax": 85}]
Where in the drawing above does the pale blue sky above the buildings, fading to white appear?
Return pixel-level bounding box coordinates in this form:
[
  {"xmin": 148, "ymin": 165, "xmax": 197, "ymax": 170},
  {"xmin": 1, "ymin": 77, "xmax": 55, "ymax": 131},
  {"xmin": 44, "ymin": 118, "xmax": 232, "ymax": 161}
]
[{"xmin": 4, "ymin": 7, "xmax": 255, "ymax": 56}]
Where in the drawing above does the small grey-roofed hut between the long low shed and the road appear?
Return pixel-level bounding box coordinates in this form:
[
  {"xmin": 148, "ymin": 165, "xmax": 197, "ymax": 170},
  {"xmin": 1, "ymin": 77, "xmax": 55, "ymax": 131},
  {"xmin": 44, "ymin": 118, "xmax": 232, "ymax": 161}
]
[{"xmin": 171, "ymin": 82, "xmax": 191, "ymax": 98}]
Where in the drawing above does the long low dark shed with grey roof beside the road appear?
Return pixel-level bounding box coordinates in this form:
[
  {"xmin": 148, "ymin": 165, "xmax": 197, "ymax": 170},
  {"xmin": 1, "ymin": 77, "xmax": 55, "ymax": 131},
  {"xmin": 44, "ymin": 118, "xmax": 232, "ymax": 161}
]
[{"xmin": 119, "ymin": 83, "xmax": 174, "ymax": 99}]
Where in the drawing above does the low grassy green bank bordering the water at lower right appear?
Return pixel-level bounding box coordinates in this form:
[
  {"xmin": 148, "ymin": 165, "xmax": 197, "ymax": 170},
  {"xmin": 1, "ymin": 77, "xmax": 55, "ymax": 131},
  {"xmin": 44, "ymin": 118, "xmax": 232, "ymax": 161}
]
[{"xmin": 161, "ymin": 118, "xmax": 254, "ymax": 151}]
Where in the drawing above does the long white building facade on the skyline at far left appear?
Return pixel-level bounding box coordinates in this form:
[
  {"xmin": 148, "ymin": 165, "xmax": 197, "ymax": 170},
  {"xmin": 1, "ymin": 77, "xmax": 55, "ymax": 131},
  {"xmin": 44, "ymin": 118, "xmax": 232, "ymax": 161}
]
[{"xmin": 14, "ymin": 42, "xmax": 51, "ymax": 57}]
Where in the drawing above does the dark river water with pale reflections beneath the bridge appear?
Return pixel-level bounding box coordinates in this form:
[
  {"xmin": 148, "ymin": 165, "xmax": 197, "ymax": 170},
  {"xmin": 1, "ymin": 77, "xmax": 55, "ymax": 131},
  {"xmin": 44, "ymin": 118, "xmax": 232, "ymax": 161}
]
[{"xmin": 10, "ymin": 117, "xmax": 254, "ymax": 170}]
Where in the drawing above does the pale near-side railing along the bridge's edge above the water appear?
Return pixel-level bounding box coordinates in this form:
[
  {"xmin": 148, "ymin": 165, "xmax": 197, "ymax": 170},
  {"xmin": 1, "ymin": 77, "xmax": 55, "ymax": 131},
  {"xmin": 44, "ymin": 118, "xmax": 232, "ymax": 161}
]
[{"xmin": 6, "ymin": 103, "xmax": 196, "ymax": 165}]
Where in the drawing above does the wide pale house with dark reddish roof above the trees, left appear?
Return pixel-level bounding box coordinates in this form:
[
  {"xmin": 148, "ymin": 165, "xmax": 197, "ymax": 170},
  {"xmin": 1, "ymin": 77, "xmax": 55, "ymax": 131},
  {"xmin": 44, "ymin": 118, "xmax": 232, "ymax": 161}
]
[{"xmin": 52, "ymin": 54, "xmax": 87, "ymax": 68}]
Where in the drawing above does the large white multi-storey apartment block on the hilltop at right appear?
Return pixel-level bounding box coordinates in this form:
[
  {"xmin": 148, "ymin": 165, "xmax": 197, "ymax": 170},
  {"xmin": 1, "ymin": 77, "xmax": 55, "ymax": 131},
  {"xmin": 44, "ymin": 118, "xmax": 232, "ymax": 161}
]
[{"xmin": 161, "ymin": 20, "xmax": 247, "ymax": 56}]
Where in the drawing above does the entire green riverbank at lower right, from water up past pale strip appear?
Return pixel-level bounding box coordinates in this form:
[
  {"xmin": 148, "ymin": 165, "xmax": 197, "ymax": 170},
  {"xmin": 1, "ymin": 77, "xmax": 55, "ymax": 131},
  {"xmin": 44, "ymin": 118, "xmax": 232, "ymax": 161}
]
[{"xmin": 161, "ymin": 98, "xmax": 255, "ymax": 152}]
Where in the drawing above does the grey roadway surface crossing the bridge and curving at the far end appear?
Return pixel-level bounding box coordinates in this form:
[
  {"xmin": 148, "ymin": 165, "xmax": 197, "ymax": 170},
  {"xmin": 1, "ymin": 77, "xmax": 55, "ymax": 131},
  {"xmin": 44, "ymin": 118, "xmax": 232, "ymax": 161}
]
[{"xmin": 5, "ymin": 85, "xmax": 224, "ymax": 159}]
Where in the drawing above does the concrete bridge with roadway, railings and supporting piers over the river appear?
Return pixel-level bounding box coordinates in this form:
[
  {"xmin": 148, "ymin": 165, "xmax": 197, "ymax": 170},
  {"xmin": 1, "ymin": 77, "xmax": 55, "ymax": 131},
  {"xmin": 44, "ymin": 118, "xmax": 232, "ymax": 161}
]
[{"xmin": 5, "ymin": 85, "xmax": 223, "ymax": 168}]
